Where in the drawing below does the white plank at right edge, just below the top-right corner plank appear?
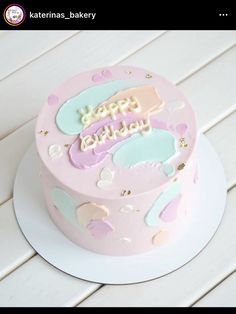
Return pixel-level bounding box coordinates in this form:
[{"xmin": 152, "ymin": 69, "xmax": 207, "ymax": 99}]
[{"xmin": 179, "ymin": 47, "xmax": 236, "ymax": 131}]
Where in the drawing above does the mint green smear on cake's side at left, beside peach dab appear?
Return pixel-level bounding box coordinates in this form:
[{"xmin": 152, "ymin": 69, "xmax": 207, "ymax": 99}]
[{"xmin": 52, "ymin": 187, "xmax": 76, "ymax": 224}]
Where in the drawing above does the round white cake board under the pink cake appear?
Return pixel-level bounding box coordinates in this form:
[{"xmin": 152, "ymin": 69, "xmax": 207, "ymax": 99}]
[{"xmin": 14, "ymin": 135, "xmax": 226, "ymax": 284}]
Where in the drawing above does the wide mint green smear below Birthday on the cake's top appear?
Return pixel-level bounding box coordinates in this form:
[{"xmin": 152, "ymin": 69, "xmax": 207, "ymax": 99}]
[{"xmin": 113, "ymin": 129, "xmax": 176, "ymax": 168}]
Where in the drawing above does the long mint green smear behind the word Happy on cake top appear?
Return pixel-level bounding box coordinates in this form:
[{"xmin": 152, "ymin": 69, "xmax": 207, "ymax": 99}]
[{"xmin": 56, "ymin": 80, "xmax": 144, "ymax": 135}]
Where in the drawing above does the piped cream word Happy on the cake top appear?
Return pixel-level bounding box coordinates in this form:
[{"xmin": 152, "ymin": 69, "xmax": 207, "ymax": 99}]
[{"xmin": 78, "ymin": 96, "xmax": 142, "ymax": 128}]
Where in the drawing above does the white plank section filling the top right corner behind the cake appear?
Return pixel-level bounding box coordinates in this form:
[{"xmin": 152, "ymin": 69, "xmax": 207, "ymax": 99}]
[{"xmin": 122, "ymin": 31, "xmax": 236, "ymax": 83}]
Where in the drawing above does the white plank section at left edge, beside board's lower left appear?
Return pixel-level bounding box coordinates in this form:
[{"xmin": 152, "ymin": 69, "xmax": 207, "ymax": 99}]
[{"xmin": 0, "ymin": 200, "xmax": 35, "ymax": 280}]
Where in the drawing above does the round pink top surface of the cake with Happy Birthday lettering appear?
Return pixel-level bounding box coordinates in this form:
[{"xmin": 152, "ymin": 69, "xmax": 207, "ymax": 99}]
[{"xmin": 36, "ymin": 66, "xmax": 197, "ymax": 198}]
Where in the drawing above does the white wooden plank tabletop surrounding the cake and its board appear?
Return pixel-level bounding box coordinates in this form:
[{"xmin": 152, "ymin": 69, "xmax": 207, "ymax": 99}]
[{"xmin": 0, "ymin": 31, "xmax": 236, "ymax": 307}]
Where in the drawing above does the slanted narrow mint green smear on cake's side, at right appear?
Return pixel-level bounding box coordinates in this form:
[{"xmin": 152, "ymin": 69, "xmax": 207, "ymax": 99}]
[{"xmin": 144, "ymin": 182, "xmax": 181, "ymax": 227}]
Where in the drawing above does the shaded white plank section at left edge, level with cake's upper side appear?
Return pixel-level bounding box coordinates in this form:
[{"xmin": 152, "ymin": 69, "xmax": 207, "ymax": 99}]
[{"xmin": 0, "ymin": 120, "xmax": 35, "ymax": 204}]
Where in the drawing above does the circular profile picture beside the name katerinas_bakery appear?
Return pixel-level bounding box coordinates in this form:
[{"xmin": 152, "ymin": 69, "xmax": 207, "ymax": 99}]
[{"xmin": 3, "ymin": 4, "xmax": 26, "ymax": 26}]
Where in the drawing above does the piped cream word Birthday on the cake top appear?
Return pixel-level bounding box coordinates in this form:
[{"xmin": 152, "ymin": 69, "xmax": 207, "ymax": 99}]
[{"xmin": 80, "ymin": 119, "xmax": 152, "ymax": 151}]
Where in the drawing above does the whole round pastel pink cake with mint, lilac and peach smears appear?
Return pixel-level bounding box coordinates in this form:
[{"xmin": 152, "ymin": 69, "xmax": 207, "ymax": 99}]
[{"xmin": 36, "ymin": 66, "xmax": 197, "ymax": 255}]
